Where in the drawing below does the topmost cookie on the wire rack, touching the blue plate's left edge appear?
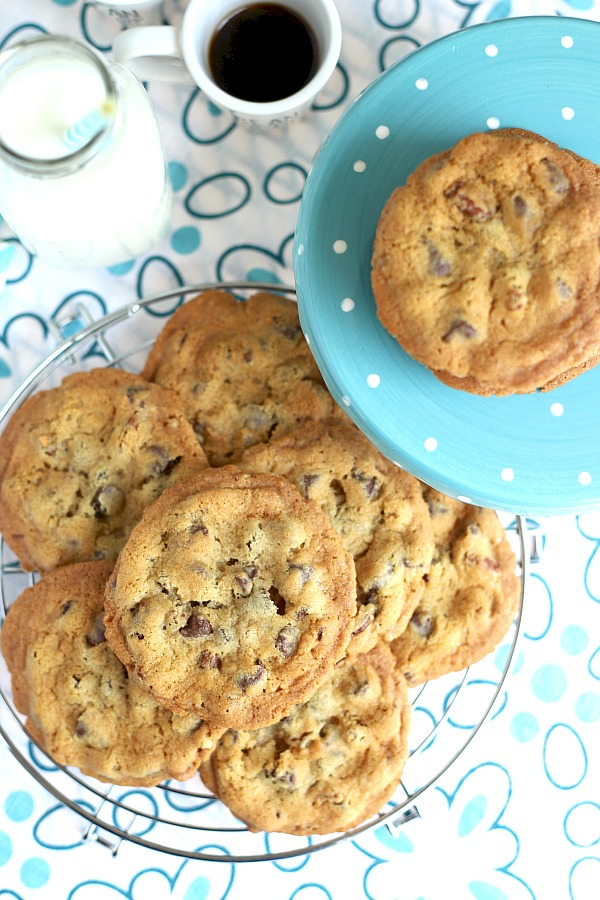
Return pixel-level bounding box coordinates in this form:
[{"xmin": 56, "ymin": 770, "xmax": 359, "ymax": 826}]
[{"xmin": 142, "ymin": 291, "xmax": 335, "ymax": 466}]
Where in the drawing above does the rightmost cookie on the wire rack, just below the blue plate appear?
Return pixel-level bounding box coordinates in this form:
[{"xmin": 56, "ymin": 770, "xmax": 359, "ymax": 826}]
[{"xmin": 391, "ymin": 486, "xmax": 520, "ymax": 685}]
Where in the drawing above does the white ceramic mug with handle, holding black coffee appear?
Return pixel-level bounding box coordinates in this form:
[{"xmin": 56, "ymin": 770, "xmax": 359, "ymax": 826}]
[{"xmin": 113, "ymin": 0, "xmax": 342, "ymax": 128}]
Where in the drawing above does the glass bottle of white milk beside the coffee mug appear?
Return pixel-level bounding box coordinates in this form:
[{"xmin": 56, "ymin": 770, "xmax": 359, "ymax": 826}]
[{"xmin": 0, "ymin": 35, "xmax": 172, "ymax": 266}]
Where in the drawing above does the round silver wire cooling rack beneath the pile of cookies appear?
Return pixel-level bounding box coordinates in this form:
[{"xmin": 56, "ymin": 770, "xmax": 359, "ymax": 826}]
[{"xmin": 0, "ymin": 282, "xmax": 537, "ymax": 863}]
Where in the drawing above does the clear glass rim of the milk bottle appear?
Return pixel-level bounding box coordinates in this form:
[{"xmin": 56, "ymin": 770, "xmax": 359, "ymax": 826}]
[{"xmin": 0, "ymin": 34, "xmax": 118, "ymax": 175}]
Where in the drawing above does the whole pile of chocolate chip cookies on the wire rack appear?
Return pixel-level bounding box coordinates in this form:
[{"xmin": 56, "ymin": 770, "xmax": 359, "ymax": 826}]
[{"xmin": 0, "ymin": 291, "xmax": 519, "ymax": 835}]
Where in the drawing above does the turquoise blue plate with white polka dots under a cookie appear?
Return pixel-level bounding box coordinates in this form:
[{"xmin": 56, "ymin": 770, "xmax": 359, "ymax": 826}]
[{"xmin": 294, "ymin": 16, "xmax": 600, "ymax": 515}]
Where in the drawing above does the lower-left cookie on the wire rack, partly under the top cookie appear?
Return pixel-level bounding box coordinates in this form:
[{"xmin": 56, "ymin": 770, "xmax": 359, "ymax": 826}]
[{"xmin": 0, "ymin": 560, "xmax": 222, "ymax": 786}]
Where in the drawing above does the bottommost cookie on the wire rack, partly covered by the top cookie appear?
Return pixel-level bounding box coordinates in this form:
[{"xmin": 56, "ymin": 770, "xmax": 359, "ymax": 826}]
[{"xmin": 200, "ymin": 644, "xmax": 411, "ymax": 835}]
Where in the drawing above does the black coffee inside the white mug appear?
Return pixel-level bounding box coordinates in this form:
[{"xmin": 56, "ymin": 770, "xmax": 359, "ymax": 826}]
[{"xmin": 208, "ymin": 3, "xmax": 319, "ymax": 103}]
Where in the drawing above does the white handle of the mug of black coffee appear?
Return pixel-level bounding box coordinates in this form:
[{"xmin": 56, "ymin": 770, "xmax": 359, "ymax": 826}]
[{"xmin": 113, "ymin": 25, "xmax": 196, "ymax": 84}]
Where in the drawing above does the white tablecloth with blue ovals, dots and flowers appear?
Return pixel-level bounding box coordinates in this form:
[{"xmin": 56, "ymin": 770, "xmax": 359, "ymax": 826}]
[{"xmin": 0, "ymin": 0, "xmax": 600, "ymax": 900}]
